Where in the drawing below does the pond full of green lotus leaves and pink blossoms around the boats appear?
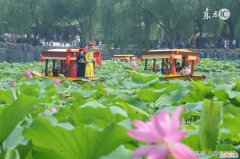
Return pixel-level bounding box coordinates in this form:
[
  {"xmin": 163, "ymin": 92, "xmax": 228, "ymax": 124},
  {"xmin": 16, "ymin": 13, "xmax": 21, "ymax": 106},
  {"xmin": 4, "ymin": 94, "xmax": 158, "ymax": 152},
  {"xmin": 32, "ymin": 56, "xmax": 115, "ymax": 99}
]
[{"xmin": 0, "ymin": 59, "xmax": 240, "ymax": 159}]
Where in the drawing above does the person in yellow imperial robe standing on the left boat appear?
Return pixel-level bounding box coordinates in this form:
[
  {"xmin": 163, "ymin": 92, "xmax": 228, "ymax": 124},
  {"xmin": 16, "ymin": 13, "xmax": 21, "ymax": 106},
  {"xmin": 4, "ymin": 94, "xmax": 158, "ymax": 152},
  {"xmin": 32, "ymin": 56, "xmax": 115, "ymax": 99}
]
[{"xmin": 85, "ymin": 43, "xmax": 94, "ymax": 78}]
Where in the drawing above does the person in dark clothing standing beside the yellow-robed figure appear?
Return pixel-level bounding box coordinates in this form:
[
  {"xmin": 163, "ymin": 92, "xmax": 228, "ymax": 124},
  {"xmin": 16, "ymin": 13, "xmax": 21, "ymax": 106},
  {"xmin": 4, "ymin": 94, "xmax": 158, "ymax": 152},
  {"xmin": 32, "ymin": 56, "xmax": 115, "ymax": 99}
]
[{"xmin": 76, "ymin": 48, "xmax": 86, "ymax": 78}]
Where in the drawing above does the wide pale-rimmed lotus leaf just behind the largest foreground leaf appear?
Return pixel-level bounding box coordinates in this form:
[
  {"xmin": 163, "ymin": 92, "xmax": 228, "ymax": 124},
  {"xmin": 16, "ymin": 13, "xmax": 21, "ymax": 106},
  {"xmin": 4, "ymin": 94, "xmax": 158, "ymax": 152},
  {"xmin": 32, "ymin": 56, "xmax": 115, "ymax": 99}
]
[{"xmin": 56, "ymin": 101, "xmax": 127, "ymax": 128}]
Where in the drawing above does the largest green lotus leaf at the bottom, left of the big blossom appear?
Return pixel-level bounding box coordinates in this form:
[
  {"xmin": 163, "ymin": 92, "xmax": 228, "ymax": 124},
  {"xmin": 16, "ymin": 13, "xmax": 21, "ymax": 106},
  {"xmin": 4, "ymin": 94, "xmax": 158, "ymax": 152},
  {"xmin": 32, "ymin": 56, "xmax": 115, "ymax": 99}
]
[{"xmin": 24, "ymin": 118, "xmax": 129, "ymax": 159}]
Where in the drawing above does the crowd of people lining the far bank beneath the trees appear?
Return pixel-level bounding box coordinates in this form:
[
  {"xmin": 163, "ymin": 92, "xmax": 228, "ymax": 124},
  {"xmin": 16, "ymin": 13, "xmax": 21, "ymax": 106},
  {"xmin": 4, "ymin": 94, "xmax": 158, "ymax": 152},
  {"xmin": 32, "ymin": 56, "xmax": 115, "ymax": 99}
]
[{"xmin": 0, "ymin": 32, "xmax": 239, "ymax": 49}]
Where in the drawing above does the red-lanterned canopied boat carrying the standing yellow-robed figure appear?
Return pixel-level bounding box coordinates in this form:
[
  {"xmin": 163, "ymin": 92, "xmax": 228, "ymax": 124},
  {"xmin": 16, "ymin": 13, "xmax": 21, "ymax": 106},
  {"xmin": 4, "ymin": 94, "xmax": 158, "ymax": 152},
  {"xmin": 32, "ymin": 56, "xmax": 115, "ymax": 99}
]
[{"xmin": 32, "ymin": 48, "xmax": 104, "ymax": 83}]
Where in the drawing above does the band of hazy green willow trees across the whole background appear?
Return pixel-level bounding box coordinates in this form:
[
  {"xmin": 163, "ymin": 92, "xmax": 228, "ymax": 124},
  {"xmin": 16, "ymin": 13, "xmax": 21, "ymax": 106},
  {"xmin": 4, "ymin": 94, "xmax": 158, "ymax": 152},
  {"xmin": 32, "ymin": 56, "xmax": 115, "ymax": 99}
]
[{"xmin": 0, "ymin": 0, "xmax": 240, "ymax": 48}]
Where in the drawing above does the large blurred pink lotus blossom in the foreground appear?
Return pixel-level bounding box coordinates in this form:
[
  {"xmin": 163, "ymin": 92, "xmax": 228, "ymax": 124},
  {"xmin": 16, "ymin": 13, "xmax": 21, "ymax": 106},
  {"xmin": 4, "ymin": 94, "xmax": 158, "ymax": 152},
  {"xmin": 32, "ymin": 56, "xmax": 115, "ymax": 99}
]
[{"xmin": 128, "ymin": 107, "xmax": 198, "ymax": 159}]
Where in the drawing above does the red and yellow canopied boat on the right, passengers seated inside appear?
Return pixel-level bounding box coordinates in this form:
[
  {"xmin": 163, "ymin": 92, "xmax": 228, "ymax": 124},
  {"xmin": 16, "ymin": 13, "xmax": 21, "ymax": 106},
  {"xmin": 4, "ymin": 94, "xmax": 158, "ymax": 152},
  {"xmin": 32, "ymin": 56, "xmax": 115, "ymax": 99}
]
[{"xmin": 141, "ymin": 49, "xmax": 206, "ymax": 80}]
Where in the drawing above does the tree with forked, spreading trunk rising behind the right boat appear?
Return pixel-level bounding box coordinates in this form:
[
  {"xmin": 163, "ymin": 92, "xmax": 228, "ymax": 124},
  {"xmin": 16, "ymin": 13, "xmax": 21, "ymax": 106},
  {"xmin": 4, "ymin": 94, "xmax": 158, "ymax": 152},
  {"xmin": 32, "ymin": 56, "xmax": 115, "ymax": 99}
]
[{"xmin": 142, "ymin": 0, "xmax": 196, "ymax": 47}]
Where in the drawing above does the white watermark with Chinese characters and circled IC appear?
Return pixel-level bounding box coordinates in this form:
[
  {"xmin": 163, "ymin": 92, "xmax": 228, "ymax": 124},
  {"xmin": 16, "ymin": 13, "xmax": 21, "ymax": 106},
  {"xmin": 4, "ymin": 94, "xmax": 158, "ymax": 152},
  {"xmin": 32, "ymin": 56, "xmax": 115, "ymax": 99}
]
[{"xmin": 203, "ymin": 8, "xmax": 231, "ymax": 20}]
